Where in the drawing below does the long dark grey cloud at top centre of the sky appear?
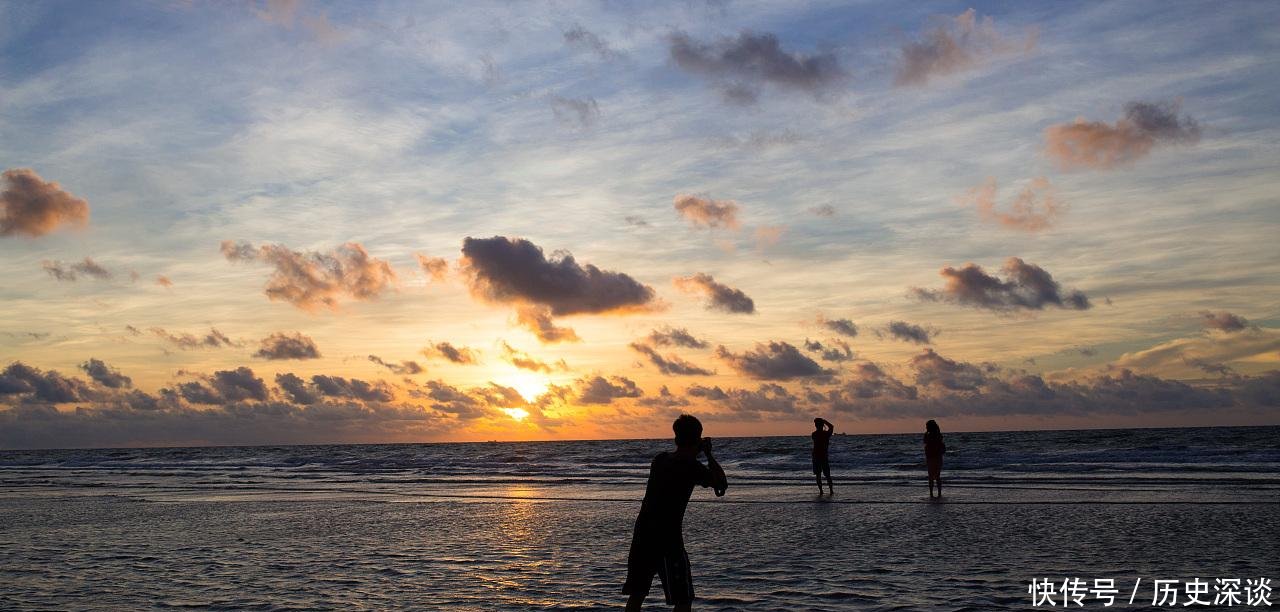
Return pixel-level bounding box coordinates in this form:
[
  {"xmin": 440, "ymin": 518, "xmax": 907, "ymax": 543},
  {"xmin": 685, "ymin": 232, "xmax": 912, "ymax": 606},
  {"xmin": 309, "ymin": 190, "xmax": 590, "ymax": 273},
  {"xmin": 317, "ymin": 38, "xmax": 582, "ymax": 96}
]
[{"xmin": 668, "ymin": 32, "xmax": 847, "ymax": 104}]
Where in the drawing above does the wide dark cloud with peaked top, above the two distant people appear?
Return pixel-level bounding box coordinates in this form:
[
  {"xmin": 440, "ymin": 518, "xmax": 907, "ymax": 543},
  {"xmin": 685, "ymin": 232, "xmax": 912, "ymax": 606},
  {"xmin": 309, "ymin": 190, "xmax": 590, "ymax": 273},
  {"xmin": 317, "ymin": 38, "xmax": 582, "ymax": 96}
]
[{"xmin": 911, "ymin": 257, "xmax": 1092, "ymax": 311}]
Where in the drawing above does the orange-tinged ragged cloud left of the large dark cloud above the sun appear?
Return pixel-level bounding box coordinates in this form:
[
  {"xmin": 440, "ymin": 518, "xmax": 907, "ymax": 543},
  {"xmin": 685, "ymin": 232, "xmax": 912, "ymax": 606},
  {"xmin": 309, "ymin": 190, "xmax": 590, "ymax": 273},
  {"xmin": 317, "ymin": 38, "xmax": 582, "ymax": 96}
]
[{"xmin": 221, "ymin": 241, "xmax": 396, "ymax": 311}]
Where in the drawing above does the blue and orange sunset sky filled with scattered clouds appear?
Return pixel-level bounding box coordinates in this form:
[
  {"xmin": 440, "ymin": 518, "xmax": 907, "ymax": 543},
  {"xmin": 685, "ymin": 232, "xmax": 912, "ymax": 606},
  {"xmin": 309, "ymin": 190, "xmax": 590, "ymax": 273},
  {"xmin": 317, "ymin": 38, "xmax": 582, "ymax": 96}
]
[{"xmin": 0, "ymin": 0, "xmax": 1280, "ymax": 448}]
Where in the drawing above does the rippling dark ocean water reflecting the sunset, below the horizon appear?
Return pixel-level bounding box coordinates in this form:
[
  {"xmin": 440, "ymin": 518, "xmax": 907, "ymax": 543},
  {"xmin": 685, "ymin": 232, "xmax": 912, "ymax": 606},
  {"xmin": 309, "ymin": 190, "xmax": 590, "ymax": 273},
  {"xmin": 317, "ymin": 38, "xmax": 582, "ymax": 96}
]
[{"xmin": 0, "ymin": 428, "xmax": 1280, "ymax": 611}]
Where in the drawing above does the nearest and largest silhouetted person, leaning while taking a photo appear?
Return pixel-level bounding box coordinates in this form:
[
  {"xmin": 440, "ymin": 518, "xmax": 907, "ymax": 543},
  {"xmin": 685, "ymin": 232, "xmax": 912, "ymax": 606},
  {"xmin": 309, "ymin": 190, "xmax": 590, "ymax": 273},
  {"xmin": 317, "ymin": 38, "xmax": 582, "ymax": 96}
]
[{"xmin": 622, "ymin": 415, "xmax": 728, "ymax": 612}]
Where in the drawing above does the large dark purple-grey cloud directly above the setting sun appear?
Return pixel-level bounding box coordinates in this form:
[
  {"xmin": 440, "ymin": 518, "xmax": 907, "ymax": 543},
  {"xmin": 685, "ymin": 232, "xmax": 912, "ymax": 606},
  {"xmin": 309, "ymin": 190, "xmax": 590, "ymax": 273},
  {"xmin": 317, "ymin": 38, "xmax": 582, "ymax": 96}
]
[{"xmin": 462, "ymin": 236, "xmax": 657, "ymax": 316}]
